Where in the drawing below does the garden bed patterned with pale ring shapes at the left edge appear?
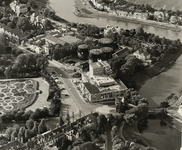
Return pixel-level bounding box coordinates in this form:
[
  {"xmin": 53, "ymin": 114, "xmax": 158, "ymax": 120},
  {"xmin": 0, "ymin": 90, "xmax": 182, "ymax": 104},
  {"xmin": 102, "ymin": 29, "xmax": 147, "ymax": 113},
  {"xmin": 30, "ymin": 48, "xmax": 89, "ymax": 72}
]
[{"xmin": 0, "ymin": 79, "xmax": 38, "ymax": 115}]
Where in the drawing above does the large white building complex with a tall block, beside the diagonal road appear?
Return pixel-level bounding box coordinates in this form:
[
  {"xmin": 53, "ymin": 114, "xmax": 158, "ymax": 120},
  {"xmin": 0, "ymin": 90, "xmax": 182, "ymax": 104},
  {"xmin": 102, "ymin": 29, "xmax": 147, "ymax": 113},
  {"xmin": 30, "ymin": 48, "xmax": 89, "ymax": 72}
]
[{"xmin": 80, "ymin": 60, "xmax": 127, "ymax": 102}]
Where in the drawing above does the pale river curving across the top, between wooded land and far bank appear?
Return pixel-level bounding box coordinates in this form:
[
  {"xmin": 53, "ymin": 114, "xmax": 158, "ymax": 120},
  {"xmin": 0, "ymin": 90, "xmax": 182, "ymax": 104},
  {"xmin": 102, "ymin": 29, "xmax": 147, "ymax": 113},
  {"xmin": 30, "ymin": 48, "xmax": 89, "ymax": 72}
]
[{"xmin": 50, "ymin": 0, "xmax": 182, "ymax": 41}]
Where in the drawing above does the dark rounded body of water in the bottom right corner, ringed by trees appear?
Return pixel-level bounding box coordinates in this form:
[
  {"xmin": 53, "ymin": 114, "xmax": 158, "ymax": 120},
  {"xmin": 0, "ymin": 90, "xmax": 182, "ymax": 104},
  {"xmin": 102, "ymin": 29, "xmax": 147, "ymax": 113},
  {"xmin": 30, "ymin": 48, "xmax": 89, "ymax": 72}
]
[{"xmin": 140, "ymin": 119, "xmax": 181, "ymax": 150}]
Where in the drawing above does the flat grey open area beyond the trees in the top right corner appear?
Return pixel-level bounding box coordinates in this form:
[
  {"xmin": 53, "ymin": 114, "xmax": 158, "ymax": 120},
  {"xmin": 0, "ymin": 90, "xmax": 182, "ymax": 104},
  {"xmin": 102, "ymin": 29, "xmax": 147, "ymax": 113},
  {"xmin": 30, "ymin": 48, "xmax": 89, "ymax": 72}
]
[{"xmin": 126, "ymin": 0, "xmax": 182, "ymax": 11}]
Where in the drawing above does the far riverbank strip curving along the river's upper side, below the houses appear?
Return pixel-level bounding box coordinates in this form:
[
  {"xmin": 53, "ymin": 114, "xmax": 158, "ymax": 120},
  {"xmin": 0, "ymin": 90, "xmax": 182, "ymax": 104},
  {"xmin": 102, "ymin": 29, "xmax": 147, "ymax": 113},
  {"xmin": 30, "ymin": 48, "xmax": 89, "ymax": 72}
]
[{"xmin": 73, "ymin": 0, "xmax": 182, "ymax": 32}]
